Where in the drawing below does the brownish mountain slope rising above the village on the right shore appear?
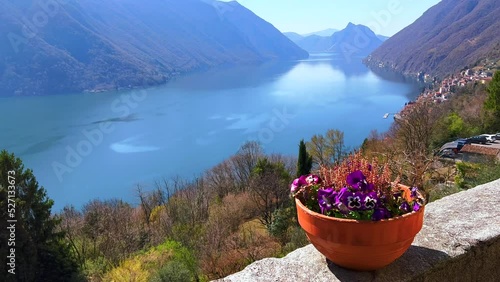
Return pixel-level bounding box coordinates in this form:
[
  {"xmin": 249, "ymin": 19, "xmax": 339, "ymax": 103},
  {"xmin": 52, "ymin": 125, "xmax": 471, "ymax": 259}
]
[{"xmin": 366, "ymin": 0, "xmax": 500, "ymax": 77}]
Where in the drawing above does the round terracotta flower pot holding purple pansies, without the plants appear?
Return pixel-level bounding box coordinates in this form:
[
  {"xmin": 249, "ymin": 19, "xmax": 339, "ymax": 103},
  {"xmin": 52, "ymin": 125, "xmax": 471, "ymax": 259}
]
[{"xmin": 295, "ymin": 199, "xmax": 425, "ymax": 271}]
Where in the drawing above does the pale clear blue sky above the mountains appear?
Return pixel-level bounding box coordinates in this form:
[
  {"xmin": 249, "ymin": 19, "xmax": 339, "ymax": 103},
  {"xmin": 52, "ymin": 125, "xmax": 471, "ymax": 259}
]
[{"xmin": 223, "ymin": 0, "xmax": 440, "ymax": 36}]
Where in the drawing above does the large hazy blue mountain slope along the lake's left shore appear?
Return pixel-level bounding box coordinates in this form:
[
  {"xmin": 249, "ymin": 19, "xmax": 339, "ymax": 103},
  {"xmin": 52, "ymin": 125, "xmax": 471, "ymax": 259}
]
[{"xmin": 0, "ymin": 0, "xmax": 307, "ymax": 95}]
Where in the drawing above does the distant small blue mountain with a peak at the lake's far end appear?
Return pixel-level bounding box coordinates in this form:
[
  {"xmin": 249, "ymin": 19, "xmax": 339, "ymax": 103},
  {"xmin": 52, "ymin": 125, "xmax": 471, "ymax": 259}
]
[{"xmin": 288, "ymin": 23, "xmax": 382, "ymax": 56}]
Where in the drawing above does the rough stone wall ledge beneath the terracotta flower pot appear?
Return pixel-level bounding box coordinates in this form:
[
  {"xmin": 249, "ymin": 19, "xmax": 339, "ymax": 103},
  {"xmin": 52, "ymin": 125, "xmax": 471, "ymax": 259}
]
[{"xmin": 218, "ymin": 180, "xmax": 500, "ymax": 282}]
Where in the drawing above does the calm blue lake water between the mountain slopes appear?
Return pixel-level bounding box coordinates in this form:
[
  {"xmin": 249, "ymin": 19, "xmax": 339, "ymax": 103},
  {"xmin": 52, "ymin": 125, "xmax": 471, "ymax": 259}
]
[{"xmin": 0, "ymin": 54, "xmax": 418, "ymax": 210}]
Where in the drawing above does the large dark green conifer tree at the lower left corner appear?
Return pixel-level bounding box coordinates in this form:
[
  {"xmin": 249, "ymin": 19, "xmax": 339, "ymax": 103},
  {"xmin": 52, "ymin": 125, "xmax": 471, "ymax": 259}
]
[{"xmin": 0, "ymin": 150, "xmax": 78, "ymax": 281}]
